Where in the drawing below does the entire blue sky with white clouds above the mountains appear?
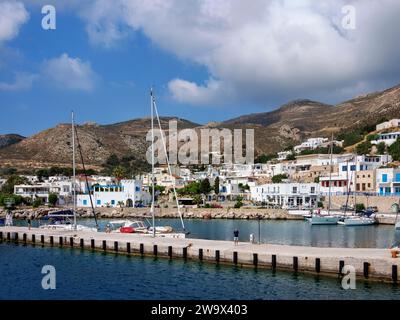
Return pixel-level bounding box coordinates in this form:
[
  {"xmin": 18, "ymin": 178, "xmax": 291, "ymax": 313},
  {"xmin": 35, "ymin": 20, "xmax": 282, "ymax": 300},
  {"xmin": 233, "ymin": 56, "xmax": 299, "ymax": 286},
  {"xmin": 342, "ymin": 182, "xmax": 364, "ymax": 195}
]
[{"xmin": 0, "ymin": 0, "xmax": 400, "ymax": 136}]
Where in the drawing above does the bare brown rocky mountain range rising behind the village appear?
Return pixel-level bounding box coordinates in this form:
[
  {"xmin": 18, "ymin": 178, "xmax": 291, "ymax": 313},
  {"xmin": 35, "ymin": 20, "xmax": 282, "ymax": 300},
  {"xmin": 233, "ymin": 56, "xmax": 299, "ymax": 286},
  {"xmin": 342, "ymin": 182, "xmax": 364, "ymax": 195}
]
[{"xmin": 0, "ymin": 86, "xmax": 400, "ymax": 169}]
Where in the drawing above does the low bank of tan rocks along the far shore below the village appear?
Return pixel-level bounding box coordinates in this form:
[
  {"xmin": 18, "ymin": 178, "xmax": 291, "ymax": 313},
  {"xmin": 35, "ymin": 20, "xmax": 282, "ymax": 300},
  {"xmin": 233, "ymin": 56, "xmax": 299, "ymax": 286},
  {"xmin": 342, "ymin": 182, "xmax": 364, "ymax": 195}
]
[{"xmin": 0, "ymin": 208, "xmax": 303, "ymax": 220}]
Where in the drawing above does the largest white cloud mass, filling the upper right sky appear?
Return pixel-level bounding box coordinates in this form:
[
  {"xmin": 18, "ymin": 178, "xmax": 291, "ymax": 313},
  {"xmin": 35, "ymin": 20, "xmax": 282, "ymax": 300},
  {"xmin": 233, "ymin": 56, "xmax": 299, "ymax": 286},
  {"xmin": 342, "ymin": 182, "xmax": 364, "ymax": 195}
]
[{"xmin": 79, "ymin": 0, "xmax": 400, "ymax": 105}]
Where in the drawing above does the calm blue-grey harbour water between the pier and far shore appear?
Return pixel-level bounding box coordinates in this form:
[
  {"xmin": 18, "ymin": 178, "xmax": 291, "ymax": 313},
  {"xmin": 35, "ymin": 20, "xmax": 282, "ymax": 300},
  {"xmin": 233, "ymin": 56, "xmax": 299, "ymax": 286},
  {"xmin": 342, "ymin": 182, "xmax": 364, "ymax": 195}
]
[{"xmin": 14, "ymin": 219, "xmax": 400, "ymax": 248}]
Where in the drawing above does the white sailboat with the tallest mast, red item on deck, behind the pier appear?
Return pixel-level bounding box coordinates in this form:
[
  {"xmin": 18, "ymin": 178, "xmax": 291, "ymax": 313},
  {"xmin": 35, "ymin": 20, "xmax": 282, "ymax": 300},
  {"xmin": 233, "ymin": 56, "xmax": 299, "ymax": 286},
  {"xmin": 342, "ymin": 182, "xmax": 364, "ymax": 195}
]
[{"xmin": 109, "ymin": 89, "xmax": 188, "ymax": 239}]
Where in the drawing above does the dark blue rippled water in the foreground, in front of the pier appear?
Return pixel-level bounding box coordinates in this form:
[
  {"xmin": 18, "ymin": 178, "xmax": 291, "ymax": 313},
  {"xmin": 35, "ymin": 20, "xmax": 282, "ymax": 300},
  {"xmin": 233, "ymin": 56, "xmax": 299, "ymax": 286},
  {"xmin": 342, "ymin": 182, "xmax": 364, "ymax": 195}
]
[{"xmin": 0, "ymin": 242, "xmax": 400, "ymax": 300}]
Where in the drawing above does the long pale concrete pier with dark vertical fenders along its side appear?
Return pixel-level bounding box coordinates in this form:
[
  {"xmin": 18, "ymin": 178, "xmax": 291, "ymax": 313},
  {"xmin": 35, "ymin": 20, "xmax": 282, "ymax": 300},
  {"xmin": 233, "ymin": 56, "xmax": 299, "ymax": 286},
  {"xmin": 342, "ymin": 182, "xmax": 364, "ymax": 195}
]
[{"xmin": 0, "ymin": 227, "xmax": 400, "ymax": 283}]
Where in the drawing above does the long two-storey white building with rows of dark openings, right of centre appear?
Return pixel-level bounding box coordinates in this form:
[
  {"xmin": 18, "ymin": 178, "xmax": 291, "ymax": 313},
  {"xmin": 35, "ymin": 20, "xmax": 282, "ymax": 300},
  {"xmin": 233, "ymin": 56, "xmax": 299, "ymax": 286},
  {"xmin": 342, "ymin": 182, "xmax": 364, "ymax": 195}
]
[{"xmin": 250, "ymin": 183, "xmax": 319, "ymax": 209}]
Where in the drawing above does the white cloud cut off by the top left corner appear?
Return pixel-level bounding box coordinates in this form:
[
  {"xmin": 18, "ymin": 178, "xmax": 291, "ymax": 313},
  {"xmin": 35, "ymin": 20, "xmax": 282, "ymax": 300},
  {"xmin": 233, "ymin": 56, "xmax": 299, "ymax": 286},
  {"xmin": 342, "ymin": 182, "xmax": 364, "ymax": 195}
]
[{"xmin": 0, "ymin": 1, "xmax": 29, "ymax": 44}]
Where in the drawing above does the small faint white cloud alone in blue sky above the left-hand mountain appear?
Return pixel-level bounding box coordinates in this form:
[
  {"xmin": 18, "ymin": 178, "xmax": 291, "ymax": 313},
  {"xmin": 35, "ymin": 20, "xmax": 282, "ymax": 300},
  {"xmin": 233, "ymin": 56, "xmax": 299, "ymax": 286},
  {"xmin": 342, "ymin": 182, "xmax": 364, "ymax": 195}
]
[{"xmin": 41, "ymin": 53, "xmax": 97, "ymax": 91}]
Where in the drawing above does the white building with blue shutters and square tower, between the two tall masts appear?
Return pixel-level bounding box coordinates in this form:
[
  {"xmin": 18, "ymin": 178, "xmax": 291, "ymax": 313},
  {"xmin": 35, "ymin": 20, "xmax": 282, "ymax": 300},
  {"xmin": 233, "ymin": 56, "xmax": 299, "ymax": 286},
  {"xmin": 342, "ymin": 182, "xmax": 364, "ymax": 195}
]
[{"xmin": 77, "ymin": 180, "xmax": 151, "ymax": 207}]
